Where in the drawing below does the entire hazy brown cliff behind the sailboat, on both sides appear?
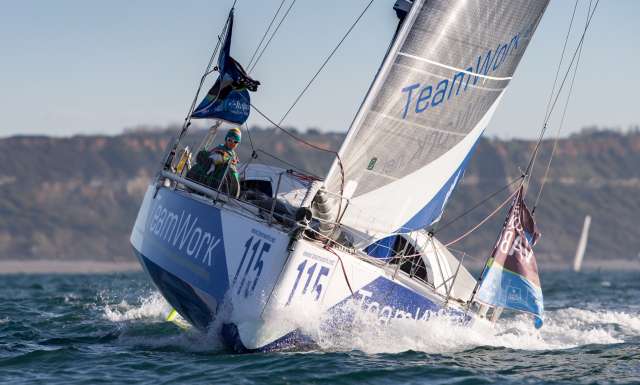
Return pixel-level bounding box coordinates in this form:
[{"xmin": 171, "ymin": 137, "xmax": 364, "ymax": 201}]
[{"xmin": 0, "ymin": 130, "xmax": 640, "ymax": 262}]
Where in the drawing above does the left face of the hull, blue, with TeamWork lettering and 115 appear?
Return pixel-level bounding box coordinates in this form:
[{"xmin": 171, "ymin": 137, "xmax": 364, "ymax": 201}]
[{"xmin": 131, "ymin": 185, "xmax": 289, "ymax": 330}]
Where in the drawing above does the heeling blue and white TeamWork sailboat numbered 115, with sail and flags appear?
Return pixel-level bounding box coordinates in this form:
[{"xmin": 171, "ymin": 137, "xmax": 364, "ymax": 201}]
[{"xmin": 131, "ymin": 0, "xmax": 548, "ymax": 352}]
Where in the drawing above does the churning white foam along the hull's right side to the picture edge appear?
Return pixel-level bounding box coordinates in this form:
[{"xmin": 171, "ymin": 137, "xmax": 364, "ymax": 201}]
[{"xmin": 292, "ymin": 302, "xmax": 640, "ymax": 353}]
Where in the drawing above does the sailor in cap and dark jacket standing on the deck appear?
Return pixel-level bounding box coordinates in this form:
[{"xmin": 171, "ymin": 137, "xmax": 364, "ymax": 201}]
[{"xmin": 187, "ymin": 128, "xmax": 242, "ymax": 197}]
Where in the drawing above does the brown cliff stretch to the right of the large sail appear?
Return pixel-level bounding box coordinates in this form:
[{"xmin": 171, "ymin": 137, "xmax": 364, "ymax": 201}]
[{"xmin": 441, "ymin": 131, "xmax": 640, "ymax": 262}]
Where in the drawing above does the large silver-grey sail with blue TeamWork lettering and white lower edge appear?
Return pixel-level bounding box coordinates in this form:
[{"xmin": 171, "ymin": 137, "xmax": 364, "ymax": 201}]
[{"xmin": 325, "ymin": 0, "xmax": 548, "ymax": 244}]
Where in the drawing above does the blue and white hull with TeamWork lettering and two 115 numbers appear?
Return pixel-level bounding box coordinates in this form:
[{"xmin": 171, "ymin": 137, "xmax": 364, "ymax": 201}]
[{"xmin": 131, "ymin": 174, "xmax": 475, "ymax": 351}]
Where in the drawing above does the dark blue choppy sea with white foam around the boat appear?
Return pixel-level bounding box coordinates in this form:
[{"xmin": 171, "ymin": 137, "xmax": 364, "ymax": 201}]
[{"xmin": 0, "ymin": 271, "xmax": 640, "ymax": 384}]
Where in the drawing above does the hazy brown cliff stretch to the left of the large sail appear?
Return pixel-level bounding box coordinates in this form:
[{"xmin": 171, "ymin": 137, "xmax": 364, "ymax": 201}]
[{"xmin": 0, "ymin": 130, "xmax": 343, "ymax": 259}]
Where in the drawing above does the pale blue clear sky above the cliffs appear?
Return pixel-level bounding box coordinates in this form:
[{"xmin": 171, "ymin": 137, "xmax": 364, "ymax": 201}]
[{"xmin": 0, "ymin": 0, "xmax": 640, "ymax": 138}]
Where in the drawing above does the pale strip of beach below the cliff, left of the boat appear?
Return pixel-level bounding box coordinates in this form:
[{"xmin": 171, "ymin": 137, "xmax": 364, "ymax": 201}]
[{"xmin": 0, "ymin": 259, "xmax": 142, "ymax": 275}]
